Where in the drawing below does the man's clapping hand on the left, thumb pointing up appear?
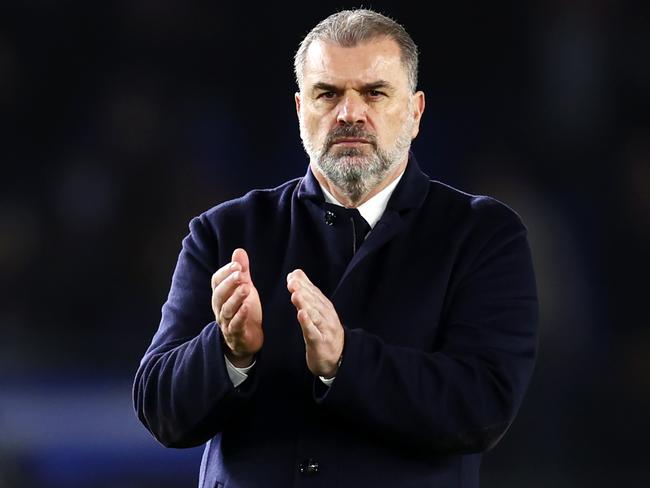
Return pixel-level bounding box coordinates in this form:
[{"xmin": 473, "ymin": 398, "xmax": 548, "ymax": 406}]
[{"xmin": 212, "ymin": 249, "xmax": 264, "ymax": 368}]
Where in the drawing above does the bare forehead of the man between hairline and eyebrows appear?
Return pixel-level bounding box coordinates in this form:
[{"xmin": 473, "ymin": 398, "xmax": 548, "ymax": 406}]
[{"xmin": 303, "ymin": 37, "xmax": 408, "ymax": 86}]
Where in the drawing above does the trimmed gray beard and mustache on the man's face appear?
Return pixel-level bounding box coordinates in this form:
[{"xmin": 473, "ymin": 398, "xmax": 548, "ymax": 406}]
[{"xmin": 303, "ymin": 124, "xmax": 412, "ymax": 206}]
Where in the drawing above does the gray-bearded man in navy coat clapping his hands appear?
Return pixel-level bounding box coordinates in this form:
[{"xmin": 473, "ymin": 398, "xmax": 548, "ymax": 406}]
[{"xmin": 134, "ymin": 10, "xmax": 537, "ymax": 488}]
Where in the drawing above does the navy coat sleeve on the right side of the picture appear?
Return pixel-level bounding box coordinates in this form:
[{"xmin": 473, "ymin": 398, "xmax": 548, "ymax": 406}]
[{"xmin": 314, "ymin": 200, "xmax": 538, "ymax": 454}]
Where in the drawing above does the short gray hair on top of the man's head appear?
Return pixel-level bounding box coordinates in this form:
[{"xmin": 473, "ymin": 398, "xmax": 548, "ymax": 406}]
[{"xmin": 293, "ymin": 9, "xmax": 418, "ymax": 92}]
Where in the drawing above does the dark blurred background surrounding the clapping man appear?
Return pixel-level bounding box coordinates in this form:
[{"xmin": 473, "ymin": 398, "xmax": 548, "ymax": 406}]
[{"xmin": 0, "ymin": 0, "xmax": 650, "ymax": 488}]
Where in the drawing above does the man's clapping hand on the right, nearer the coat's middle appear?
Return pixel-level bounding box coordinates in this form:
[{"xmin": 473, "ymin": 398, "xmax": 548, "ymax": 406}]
[{"xmin": 287, "ymin": 269, "xmax": 345, "ymax": 378}]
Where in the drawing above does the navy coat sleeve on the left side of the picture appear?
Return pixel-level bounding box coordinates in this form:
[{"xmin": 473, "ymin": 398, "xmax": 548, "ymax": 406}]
[{"xmin": 133, "ymin": 216, "xmax": 256, "ymax": 447}]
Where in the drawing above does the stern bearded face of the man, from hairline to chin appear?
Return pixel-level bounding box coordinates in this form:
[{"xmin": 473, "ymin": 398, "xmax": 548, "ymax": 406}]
[{"xmin": 296, "ymin": 37, "xmax": 424, "ymax": 203}]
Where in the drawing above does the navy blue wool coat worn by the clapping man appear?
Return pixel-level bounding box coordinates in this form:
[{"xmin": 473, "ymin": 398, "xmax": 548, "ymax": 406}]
[{"xmin": 133, "ymin": 157, "xmax": 537, "ymax": 488}]
